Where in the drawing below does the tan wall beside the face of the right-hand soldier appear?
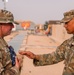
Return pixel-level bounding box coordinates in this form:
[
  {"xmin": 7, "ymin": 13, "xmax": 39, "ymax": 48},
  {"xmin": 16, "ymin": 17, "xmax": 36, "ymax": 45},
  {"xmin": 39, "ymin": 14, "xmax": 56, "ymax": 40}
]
[{"xmin": 52, "ymin": 24, "xmax": 72, "ymax": 43}]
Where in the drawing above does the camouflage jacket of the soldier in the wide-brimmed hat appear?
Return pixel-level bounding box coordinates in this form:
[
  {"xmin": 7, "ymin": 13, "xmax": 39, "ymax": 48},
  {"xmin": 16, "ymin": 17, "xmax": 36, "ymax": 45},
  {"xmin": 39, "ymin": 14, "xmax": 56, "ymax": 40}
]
[{"xmin": 0, "ymin": 38, "xmax": 19, "ymax": 75}]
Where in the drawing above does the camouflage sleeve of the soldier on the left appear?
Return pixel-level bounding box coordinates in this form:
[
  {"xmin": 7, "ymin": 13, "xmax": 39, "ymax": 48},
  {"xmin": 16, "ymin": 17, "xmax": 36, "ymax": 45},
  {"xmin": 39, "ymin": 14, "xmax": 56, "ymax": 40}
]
[{"xmin": 0, "ymin": 51, "xmax": 19, "ymax": 75}]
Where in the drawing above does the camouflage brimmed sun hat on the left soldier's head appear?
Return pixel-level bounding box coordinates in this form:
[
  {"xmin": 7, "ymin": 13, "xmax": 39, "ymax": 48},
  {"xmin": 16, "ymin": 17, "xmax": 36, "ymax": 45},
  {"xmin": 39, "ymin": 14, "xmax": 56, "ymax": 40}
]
[{"xmin": 0, "ymin": 9, "xmax": 17, "ymax": 24}]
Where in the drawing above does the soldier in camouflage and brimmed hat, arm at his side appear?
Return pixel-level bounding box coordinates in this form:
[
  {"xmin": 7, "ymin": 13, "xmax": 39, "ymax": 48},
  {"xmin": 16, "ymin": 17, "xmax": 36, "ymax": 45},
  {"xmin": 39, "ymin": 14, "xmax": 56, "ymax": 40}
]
[{"xmin": 0, "ymin": 9, "xmax": 19, "ymax": 75}]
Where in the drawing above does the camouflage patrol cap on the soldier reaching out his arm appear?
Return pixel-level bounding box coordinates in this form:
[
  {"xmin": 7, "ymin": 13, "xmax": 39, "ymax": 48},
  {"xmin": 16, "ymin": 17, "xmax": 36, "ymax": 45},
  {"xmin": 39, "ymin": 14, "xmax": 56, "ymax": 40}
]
[{"xmin": 61, "ymin": 10, "xmax": 74, "ymax": 23}]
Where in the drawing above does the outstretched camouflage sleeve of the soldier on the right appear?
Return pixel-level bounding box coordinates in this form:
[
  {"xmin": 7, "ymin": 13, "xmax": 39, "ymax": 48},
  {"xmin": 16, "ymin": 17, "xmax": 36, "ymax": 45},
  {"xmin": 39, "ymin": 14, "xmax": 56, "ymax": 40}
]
[{"xmin": 33, "ymin": 41, "xmax": 67, "ymax": 66}]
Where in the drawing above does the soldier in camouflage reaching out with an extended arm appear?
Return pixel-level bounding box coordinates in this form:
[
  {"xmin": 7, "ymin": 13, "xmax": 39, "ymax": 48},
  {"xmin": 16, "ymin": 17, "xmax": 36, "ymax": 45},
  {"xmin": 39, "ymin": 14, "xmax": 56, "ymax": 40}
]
[{"xmin": 19, "ymin": 10, "xmax": 74, "ymax": 75}]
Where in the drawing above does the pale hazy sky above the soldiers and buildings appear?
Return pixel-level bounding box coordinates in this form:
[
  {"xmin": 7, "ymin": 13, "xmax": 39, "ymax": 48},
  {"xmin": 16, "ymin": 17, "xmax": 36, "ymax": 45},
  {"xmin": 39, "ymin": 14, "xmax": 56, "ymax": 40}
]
[{"xmin": 0, "ymin": 0, "xmax": 74, "ymax": 24}]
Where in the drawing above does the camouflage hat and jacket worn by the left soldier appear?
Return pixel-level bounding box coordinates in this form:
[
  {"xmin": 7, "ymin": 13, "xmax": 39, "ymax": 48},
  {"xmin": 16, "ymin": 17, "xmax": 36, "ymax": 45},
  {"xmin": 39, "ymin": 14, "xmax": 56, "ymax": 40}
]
[{"xmin": 0, "ymin": 9, "xmax": 19, "ymax": 75}]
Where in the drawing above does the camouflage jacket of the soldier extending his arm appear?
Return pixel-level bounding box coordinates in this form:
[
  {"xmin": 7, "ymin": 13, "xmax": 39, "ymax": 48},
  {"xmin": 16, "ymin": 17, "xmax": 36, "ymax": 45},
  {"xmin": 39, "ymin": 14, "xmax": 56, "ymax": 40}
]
[{"xmin": 33, "ymin": 36, "xmax": 74, "ymax": 75}]
